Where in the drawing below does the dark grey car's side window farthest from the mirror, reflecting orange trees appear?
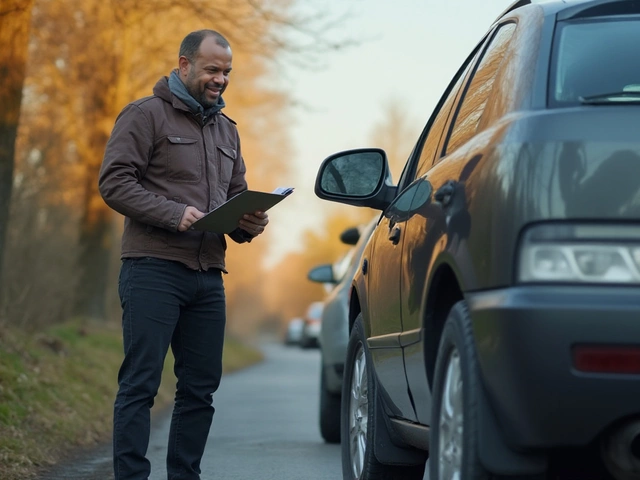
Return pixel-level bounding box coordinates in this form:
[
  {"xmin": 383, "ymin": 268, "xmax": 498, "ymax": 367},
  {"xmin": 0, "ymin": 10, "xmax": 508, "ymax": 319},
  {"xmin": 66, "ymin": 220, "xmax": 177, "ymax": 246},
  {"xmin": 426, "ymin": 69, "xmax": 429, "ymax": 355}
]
[{"xmin": 445, "ymin": 23, "xmax": 516, "ymax": 153}]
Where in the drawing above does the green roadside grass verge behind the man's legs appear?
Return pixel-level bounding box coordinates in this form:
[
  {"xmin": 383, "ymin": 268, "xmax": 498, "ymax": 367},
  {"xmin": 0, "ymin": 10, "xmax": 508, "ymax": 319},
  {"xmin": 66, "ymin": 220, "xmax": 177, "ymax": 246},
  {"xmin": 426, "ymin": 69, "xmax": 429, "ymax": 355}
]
[{"xmin": 0, "ymin": 323, "xmax": 262, "ymax": 480}]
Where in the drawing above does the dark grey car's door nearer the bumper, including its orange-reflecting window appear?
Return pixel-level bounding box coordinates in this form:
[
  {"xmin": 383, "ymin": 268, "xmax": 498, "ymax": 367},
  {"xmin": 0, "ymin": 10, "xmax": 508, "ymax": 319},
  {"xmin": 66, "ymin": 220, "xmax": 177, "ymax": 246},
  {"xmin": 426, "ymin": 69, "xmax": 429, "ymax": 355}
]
[{"xmin": 400, "ymin": 23, "xmax": 516, "ymax": 424}]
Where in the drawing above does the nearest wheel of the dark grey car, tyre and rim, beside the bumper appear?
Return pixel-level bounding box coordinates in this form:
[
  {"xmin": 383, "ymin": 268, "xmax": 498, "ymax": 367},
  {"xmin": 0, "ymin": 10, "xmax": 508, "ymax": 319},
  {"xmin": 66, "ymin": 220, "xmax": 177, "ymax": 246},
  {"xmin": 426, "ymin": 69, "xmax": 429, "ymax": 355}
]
[{"xmin": 429, "ymin": 301, "xmax": 491, "ymax": 480}]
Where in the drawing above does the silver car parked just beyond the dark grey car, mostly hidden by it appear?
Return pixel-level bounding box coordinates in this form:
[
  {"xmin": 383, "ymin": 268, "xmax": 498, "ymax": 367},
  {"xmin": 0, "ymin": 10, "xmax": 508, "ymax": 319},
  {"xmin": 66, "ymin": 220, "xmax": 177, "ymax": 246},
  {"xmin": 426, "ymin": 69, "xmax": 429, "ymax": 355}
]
[{"xmin": 308, "ymin": 216, "xmax": 378, "ymax": 443}]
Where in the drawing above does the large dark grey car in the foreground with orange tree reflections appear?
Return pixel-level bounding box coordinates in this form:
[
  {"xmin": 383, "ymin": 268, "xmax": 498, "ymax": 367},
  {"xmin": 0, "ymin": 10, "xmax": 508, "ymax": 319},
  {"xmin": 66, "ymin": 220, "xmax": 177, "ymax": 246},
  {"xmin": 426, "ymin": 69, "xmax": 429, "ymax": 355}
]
[{"xmin": 316, "ymin": 0, "xmax": 640, "ymax": 480}]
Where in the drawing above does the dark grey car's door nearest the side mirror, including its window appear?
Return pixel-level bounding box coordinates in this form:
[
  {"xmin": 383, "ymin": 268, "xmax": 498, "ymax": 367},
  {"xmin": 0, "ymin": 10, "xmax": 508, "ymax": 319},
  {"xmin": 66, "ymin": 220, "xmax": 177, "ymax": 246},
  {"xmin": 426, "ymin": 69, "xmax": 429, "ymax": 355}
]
[{"xmin": 365, "ymin": 35, "xmax": 488, "ymax": 421}]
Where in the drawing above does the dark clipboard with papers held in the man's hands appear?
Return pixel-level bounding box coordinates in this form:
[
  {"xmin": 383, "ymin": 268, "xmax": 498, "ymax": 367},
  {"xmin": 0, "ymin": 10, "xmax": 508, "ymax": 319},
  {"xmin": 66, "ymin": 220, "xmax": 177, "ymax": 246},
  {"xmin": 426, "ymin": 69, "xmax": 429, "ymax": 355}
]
[{"xmin": 191, "ymin": 187, "xmax": 293, "ymax": 233}]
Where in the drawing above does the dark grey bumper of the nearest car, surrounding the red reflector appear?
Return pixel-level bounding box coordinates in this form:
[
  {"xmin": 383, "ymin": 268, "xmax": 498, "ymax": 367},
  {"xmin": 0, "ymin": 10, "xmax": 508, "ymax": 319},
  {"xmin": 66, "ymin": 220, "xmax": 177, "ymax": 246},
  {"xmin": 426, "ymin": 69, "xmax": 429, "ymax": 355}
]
[{"xmin": 465, "ymin": 286, "xmax": 640, "ymax": 449}]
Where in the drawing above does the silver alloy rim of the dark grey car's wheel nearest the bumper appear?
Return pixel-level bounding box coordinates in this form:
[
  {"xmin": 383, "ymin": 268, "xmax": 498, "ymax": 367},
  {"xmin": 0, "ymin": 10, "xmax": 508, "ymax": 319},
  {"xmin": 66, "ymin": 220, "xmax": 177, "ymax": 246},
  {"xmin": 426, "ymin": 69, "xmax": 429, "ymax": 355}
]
[{"xmin": 438, "ymin": 349, "xmax": 464, "ymax": 480}]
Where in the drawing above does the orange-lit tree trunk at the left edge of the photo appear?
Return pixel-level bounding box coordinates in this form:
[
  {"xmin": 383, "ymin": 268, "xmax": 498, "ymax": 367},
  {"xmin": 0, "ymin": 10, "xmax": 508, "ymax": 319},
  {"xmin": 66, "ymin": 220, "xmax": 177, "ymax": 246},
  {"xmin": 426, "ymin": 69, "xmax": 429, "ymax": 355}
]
[{"xmin": 0, "ymin": 0, "xmax": 33, "ymax": 284}]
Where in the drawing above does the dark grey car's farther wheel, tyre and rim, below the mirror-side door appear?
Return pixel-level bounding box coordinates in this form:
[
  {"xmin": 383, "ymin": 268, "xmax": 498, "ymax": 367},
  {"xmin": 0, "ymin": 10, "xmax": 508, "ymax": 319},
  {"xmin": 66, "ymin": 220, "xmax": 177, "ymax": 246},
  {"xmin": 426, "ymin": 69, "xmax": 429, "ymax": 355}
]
[{"xmin": 340, "ymin": 314, "xmax": 424, "ymax": 480}]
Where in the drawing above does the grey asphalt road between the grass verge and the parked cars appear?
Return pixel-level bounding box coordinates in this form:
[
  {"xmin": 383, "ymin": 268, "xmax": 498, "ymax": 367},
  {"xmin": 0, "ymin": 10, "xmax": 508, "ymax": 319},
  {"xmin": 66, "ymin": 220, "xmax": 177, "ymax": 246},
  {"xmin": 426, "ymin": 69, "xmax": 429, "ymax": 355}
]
[{"xmin": 39, "ymin": 344, "xmax": 342, "ymax": 480}]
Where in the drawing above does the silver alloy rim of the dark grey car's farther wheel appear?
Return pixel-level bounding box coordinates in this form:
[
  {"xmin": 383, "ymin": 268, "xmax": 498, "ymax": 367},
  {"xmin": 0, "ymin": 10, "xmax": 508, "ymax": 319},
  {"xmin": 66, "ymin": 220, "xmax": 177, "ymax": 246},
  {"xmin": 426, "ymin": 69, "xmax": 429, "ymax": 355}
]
[{"xmin": 349, "ymin": 345, "xmax": 369, "ymax": 478}]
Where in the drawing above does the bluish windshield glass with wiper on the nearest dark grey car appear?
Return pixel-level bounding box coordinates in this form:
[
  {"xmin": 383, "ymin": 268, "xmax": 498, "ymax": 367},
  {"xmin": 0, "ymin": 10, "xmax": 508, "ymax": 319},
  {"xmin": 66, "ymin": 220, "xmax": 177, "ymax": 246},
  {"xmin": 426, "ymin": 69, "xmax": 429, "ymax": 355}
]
[{"xmin": 550, "ymin": 17, "xmax": 640, "ymax": 105}]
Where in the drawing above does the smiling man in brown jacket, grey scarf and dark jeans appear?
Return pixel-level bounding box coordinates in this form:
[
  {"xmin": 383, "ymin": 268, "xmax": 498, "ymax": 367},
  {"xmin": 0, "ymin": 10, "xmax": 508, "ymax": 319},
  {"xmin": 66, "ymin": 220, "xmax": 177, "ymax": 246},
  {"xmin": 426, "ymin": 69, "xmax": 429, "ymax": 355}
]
[{"xmin": 99, "ymin": 30, "xmax": 269, "ymax": 480}]
